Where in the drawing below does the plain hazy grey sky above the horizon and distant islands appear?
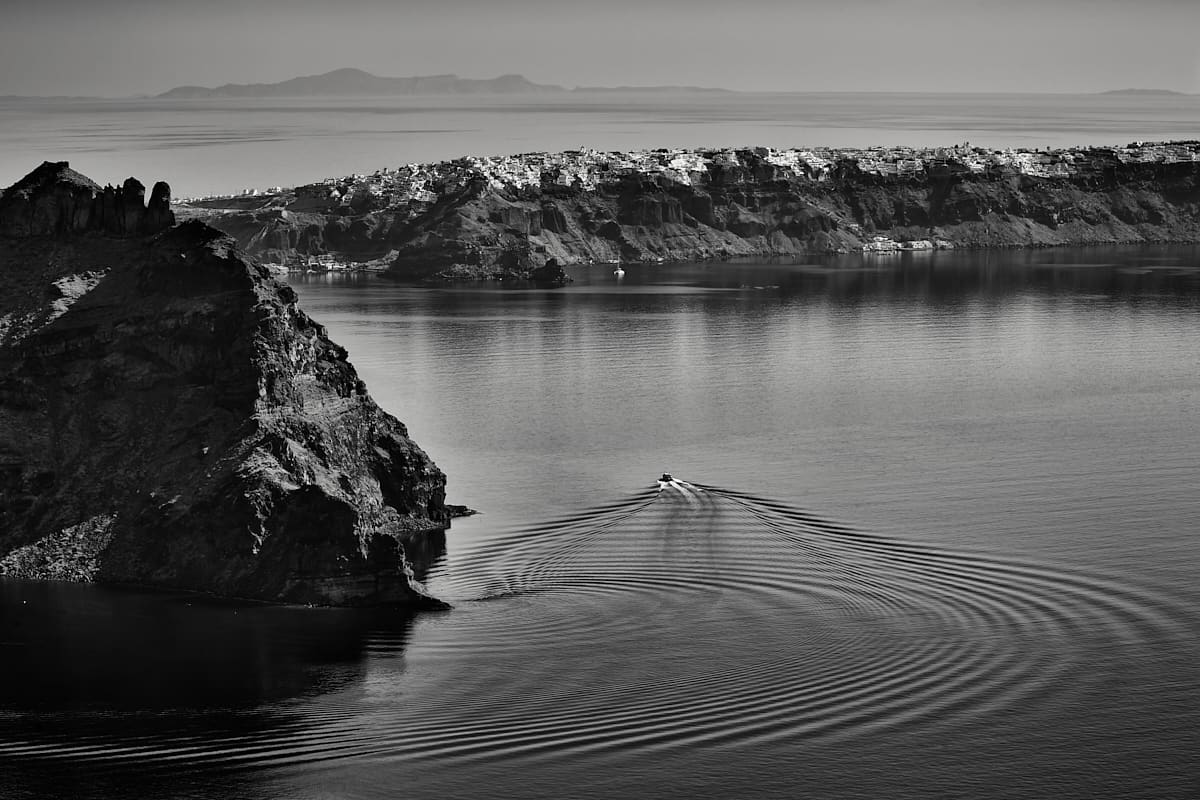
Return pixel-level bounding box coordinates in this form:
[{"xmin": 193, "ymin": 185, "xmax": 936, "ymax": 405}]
[{"xmin": 7, "ymin": 0, "xmax": 1200, "ymax": 96}]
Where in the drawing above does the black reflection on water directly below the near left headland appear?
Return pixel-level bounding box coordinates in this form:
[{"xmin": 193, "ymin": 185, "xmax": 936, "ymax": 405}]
[{"xmin": 0, "ymin": 581, "xmax": 427, "ymax": 714}]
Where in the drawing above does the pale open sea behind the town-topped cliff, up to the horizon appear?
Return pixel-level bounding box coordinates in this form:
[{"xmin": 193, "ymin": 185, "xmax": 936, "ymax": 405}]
[{"xmin": 7, "ymin": 92, "xmax": 1200, "ymax": 197}]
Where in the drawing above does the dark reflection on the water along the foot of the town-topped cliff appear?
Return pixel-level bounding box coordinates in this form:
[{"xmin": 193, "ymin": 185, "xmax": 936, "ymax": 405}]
[{"xmin": 289, "ymin": 245, "xmax": 1200, "ymax": 309}]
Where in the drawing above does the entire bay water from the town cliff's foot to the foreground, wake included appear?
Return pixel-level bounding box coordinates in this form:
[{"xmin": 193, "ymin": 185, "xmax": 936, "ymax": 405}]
[{"xmin": 0, "ymin": 248, "xmax": 1200, "ymax": 799}]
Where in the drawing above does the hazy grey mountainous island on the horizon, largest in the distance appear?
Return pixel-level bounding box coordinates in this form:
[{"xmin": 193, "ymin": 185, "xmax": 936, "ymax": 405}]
[{"xmin": 155, "ymin": 68, "xmax": 728, "ymax": 100}]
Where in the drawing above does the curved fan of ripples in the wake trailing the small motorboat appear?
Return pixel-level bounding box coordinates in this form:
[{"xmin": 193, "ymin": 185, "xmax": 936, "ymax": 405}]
[{"xmin": 0, "ymin": 481, "xmax": 1195, "ymax": 766}]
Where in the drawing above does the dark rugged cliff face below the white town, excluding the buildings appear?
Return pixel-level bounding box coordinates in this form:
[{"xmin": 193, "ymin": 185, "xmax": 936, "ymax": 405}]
[{"xmin": 188, "ymin": 150, "xmax": 1200, "ymax": 281}]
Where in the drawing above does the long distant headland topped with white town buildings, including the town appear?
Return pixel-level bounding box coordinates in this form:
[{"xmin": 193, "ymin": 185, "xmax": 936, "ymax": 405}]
[{"xmin": 176, "ymin": 142, "xmax": 1200, "ymax": 283}]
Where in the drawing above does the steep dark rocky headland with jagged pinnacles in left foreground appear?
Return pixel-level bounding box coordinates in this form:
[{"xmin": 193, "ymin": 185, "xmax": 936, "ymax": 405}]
[{"xmin": 0, "ymin": 162, "xmax": 449, "ymax": 607}]
